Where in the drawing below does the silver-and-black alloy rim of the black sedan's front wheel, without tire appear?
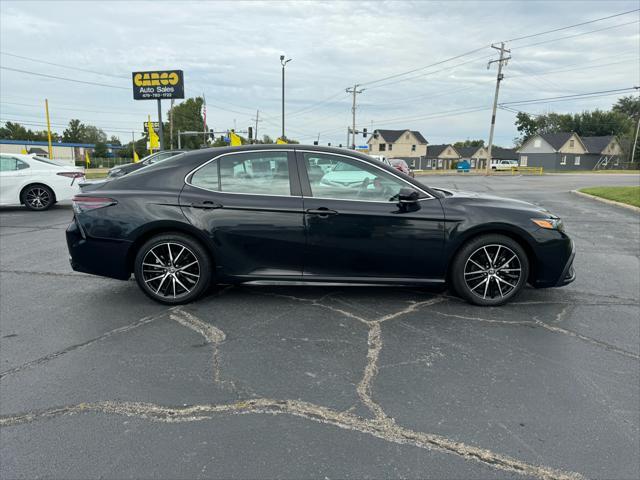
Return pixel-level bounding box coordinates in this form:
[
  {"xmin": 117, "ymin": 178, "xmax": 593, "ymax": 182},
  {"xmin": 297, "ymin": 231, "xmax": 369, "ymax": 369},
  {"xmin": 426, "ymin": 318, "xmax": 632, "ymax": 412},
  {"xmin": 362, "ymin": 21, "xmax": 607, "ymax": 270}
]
[{"xmin": 464, "ymin": 244, "xmax": 522, "ymax": 300}]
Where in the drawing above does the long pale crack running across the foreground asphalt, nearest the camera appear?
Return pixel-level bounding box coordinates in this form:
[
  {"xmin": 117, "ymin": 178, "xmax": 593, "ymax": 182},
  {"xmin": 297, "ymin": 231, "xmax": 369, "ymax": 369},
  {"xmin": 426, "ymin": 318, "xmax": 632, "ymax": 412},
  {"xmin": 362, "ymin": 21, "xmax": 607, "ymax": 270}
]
[{"xmin": 0, "ymin": 398, "xmax": 583, "ymax": 480}]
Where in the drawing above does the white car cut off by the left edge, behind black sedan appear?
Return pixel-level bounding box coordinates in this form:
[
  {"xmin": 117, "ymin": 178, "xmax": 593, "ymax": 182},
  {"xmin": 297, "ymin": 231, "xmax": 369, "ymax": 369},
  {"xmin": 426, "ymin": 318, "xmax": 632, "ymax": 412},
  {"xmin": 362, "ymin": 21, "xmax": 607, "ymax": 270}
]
[{"xmin": 0, "ymin": 153, "xmax": 84, "ymax": 210}]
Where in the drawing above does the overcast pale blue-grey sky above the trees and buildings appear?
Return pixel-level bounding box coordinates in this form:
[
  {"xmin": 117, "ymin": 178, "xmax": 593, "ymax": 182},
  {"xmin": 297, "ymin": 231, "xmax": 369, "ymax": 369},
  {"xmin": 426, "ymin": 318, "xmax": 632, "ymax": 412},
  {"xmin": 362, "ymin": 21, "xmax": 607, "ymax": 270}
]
[{"xmin": 0, "ymin": 0, "xmax": 640, "ymax": 146}]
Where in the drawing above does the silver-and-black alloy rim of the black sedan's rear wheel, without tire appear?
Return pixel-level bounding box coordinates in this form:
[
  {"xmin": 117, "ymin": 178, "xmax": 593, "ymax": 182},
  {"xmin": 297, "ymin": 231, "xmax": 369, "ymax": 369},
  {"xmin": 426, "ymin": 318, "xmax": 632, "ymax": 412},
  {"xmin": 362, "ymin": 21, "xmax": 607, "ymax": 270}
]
[{"xmin": 142, "ymin": 242, "xmax": 201, "ymax": 299}]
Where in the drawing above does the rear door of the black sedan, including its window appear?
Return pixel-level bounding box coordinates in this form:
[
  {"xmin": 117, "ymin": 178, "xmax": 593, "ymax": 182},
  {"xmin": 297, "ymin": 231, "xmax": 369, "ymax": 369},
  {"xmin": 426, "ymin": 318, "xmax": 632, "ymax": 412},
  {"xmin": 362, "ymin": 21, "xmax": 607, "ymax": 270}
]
[{"xmin": 180, "ymin": 150, "xmax": 305, "ymax": 277}]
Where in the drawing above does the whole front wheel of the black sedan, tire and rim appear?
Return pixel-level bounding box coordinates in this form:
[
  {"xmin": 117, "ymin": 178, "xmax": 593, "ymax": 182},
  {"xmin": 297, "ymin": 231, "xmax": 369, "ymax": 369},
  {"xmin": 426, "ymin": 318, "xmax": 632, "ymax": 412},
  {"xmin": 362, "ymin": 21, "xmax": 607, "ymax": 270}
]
[{"xmin": 451, "ymin": 234, "xmax": 529, "ymax": 306}]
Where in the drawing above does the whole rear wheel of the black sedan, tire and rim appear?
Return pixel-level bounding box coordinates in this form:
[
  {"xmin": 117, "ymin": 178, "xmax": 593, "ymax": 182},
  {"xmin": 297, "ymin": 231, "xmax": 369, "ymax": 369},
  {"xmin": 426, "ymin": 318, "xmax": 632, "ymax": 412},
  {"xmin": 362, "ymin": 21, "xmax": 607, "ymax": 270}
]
[{"xmin": 134, "ymin": 232, "xmax": 212, "ymax": 305}]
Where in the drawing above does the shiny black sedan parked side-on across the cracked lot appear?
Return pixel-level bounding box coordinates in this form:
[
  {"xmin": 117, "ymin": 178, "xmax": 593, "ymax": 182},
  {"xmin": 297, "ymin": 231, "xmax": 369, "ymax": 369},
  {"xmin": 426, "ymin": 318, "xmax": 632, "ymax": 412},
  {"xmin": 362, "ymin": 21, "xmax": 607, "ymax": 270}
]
[{"xmin": 67, "ymin": 145, "xmax": 575, "ymax": 305}]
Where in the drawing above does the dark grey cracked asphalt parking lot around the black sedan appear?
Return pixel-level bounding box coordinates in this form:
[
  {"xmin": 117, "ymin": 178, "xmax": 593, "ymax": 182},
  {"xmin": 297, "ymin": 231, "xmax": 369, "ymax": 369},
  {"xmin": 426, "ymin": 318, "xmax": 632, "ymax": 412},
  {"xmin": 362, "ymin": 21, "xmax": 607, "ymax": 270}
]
[{"xmin": 0, "ymin": 175, "xmax": 640, "ymax": 479}]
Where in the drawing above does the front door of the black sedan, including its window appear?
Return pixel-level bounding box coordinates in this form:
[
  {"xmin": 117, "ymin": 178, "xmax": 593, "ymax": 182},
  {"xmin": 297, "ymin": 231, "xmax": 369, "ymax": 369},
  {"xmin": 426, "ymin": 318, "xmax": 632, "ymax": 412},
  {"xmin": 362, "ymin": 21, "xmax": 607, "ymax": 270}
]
[{"xmin": 298, "ymin": 152, "xmax": 445, "ymax": 281}]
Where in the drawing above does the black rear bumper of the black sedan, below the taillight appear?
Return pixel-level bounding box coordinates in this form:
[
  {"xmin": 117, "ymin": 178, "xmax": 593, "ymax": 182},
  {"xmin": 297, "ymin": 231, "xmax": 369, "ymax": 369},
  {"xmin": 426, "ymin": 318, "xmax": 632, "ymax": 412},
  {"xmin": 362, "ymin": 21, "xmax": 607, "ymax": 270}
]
[{"xmin": 66, "ymin": 218, "xmax": 131, "ymax": 280}]
